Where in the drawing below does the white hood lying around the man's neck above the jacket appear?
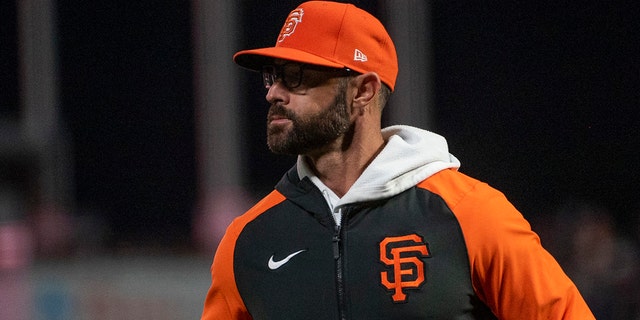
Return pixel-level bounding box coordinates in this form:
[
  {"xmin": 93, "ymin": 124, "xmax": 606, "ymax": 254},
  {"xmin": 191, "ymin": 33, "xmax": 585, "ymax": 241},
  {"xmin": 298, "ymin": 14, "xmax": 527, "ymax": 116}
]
[{"xmin": 298, "ymin": 125, "xmax": 460, "ymax": 208}]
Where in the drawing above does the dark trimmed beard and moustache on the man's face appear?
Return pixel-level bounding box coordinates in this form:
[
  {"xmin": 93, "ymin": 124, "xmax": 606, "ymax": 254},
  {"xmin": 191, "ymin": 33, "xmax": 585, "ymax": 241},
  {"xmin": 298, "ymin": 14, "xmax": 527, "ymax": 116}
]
[{"xmin": 267, "ymin": 84, "xmax": 351, "ymax": 155}]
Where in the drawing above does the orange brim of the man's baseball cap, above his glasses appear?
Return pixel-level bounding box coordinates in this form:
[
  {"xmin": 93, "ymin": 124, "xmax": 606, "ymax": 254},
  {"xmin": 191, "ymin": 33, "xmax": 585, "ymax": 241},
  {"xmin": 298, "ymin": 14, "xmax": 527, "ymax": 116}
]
[{"xmin": 233, "ymin": 47, "xmax": 344, "ymax": 71}]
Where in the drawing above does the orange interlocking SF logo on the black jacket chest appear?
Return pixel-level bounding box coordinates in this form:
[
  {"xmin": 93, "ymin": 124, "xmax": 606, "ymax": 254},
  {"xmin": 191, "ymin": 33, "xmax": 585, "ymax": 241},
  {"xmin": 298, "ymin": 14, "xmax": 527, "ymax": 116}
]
[{"xmin": 380, "ymin": 234, "xmax": 429, "ymax": 303}]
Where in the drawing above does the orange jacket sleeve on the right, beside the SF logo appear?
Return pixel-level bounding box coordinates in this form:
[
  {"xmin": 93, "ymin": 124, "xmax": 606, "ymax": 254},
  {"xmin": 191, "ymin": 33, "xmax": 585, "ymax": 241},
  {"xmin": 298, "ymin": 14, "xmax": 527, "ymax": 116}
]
[{"xmin": 420, "ymin": 170, "xmax": 595, "ymax": 320}]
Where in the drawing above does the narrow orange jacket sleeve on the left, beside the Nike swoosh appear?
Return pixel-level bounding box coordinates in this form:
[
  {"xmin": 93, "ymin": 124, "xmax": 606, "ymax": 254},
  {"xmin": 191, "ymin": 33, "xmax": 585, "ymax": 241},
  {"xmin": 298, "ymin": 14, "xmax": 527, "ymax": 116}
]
[{"xmin": 201, "ymin": 191, "xmax": 285, "ymax": 320}]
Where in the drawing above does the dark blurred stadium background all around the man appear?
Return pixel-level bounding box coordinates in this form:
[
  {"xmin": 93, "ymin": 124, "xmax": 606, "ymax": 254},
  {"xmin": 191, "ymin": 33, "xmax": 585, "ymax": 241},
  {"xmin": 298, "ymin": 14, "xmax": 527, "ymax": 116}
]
[{"xmin": 0, "ymin": 0, "xmax": 640, "ymax": 320}]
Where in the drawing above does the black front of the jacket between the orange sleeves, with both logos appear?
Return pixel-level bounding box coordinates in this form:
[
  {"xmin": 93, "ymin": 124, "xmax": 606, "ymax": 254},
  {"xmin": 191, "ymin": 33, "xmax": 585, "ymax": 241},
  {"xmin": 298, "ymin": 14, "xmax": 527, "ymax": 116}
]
[{"xmin": 234, "ymin": 190, "xmax": 496, "ymax": 319}]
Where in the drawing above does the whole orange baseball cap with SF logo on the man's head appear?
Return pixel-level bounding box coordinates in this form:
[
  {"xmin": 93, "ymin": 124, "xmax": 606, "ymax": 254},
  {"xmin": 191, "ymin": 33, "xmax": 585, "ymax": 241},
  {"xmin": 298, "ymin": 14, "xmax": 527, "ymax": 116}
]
[{"xmin": 233, "ymin": 1, "xmax": 398, "ymax": 91}]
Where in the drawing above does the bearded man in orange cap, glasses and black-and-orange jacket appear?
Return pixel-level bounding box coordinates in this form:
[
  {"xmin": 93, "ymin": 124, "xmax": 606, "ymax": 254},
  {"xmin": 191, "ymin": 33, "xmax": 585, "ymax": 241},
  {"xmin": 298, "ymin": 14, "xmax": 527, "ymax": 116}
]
[{"xmin": 202, "ymin": 1, "xmax": 593, "ymax": 320}]
